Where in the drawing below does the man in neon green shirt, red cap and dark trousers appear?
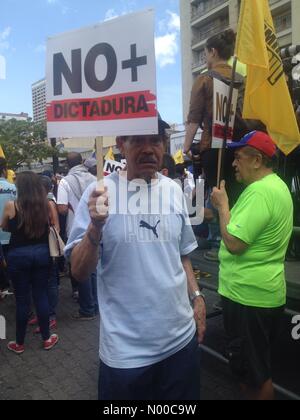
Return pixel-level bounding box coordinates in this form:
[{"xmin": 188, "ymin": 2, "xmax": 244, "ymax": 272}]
[{"xmin": 212, "ymin": 131, "xmax": 293, "ymax": 400}]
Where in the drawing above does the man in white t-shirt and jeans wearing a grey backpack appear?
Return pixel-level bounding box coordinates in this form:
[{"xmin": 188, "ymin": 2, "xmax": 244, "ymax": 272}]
[{"xmin": 57, "ymin": 153, "xmax": 98, "ymax": 320}]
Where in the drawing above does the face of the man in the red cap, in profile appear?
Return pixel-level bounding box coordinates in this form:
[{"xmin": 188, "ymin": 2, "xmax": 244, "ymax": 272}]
[{"xmin": 232, "ymin": 148, "xmax": 259, "ymax": 185}]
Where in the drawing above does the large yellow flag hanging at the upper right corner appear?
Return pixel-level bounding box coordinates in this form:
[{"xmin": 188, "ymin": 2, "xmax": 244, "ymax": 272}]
[{"xmin": 235, "ymin": 0, "xmax": 300, "ymax": 155}]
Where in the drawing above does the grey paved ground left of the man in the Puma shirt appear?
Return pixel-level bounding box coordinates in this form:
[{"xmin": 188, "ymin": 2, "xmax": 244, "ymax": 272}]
[{"xmin": 0, "ymin": 278, "xmax": 99, "ymax": 400}]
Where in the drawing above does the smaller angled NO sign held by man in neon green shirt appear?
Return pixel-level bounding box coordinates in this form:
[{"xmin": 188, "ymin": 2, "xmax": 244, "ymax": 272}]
[{"xmin": 212, "ymin": 78, "xmax": 238, "ymax": 149}]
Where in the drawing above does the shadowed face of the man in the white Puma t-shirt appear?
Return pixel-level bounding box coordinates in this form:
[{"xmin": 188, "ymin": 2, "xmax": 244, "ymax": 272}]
[{"xmin": 119, "ymin": 135, "xmax": 165, "ymax": 181}]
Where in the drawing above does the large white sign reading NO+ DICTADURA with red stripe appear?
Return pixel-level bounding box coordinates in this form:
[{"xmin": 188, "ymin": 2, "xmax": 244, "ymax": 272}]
[{"xmin": 46, "ymin": 10, "xmax": 158, "ymax": 137}]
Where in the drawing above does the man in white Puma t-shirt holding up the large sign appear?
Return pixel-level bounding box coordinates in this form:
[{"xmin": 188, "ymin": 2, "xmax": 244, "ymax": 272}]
[{"xmin": 66, "ymin": 120, "xmax": 206, "ymax": 400}]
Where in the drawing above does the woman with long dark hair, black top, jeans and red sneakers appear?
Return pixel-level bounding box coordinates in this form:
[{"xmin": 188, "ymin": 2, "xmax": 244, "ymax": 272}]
[{"xmin": 2, "ymin": 172, "xmax": 58, "ymax": 354}]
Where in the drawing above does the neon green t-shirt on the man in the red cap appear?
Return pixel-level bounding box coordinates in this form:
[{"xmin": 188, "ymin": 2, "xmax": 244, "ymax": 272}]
[{"xmin": 219, "ymin": 174, "xmax": 293, "ymax": 308}]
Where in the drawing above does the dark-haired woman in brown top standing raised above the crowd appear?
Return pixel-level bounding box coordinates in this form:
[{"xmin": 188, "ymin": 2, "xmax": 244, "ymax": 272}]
[{"xmin": 184, "ymin": 29, "xmax": 246, "ymax": 261}]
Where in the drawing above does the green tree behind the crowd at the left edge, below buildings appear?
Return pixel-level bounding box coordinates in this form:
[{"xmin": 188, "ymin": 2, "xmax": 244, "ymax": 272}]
[{"xmin": 0, "ymin": 119, "xmax": 59, "ymax": 170}]
